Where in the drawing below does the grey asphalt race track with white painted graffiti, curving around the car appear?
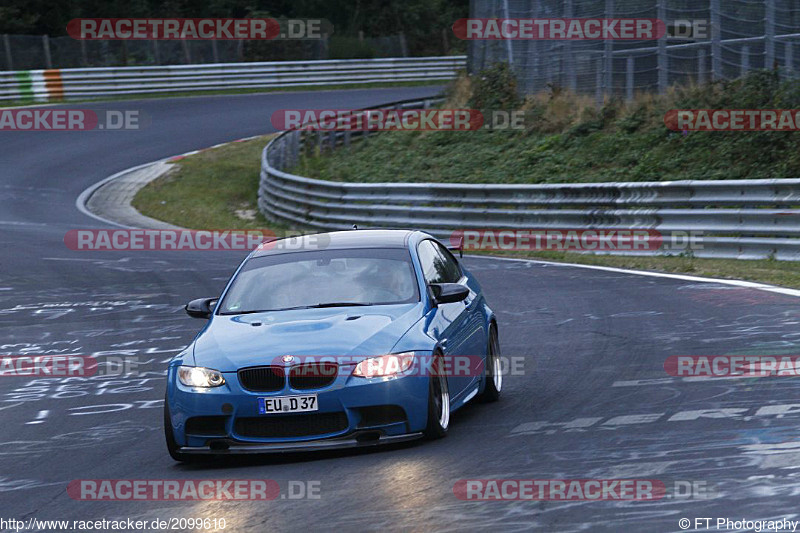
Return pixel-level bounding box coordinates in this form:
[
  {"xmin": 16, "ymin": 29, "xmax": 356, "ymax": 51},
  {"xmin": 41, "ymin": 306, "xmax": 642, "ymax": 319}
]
[{"xmin": 0, "ymin": 87, "xmax": 800, "ymax": 532}]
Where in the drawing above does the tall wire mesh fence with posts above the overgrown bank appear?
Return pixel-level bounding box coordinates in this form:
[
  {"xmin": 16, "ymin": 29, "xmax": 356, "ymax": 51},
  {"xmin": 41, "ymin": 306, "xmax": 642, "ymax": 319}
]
[{"xmin": 469, "ymin": 0, "xmax": 800, "ymax": 100}]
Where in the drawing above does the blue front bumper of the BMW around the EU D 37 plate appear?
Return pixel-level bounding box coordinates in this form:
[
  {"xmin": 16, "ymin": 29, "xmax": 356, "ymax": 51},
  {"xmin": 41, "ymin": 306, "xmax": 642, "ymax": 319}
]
[{"xmin": 166, "ymin": 367, "xmax": 429, "ymax": 448}]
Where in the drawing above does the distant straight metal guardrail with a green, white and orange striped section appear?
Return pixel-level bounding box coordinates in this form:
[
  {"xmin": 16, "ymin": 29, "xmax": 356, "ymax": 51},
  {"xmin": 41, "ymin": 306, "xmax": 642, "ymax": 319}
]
[{"xmin": 0, "ymin": 56, "xmax": 466, "ymax": 101}]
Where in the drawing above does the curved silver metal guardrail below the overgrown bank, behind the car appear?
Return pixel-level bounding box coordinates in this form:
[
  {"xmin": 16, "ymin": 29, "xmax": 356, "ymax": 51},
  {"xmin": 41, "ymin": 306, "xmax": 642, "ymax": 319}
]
[{"xmin": 258, "ymin": 99, "xmax": 800, "ymax": 261}]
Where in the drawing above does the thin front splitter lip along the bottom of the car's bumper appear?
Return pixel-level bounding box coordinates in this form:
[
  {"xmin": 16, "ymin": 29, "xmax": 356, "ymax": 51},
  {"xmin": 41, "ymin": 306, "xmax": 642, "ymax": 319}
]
[{"xmin": 178, "ymin": 431, "xmax": 422, "ymax": 455}]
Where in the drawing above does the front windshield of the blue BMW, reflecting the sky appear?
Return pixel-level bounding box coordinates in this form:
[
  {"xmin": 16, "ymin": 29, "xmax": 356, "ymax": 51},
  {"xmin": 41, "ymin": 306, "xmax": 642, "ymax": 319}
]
[{"xmin": 219, "ymin": 248, "xmax": 419, "ymax": 315}]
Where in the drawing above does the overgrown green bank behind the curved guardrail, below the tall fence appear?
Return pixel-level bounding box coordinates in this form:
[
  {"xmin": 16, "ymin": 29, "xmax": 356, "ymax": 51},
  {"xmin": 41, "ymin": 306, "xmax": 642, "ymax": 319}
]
[{"xmin": 295, "ymin": 67, "xmax": 800, "ymax": 183}]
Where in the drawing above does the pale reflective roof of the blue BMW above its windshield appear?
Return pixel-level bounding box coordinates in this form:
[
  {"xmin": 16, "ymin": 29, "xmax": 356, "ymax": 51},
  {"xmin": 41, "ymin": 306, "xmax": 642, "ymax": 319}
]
[{"xmin": 253, "ymin": 229, "xmax": 428, "ymax": 257}]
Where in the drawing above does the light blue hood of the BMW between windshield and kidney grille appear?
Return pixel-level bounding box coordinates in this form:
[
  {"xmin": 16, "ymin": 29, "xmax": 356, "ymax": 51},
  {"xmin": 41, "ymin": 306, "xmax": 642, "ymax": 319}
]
[{"xmin": 193, "ymin": 303, "xmax": 423, "ymax": 372}]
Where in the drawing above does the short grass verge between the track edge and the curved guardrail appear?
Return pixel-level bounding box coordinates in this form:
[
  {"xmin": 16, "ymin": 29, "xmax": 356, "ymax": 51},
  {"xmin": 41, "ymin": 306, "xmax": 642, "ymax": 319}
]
[{"xmin": 133, "ymin": 136, "xmax": 800, "ymax": 289}]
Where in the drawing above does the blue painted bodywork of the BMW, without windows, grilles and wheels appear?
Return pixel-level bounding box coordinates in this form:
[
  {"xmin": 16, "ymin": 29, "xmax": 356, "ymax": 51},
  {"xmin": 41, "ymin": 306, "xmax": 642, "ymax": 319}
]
[{"xmin": 166, "ymin": 230, "xmax": 494, "ymax": 453}]
